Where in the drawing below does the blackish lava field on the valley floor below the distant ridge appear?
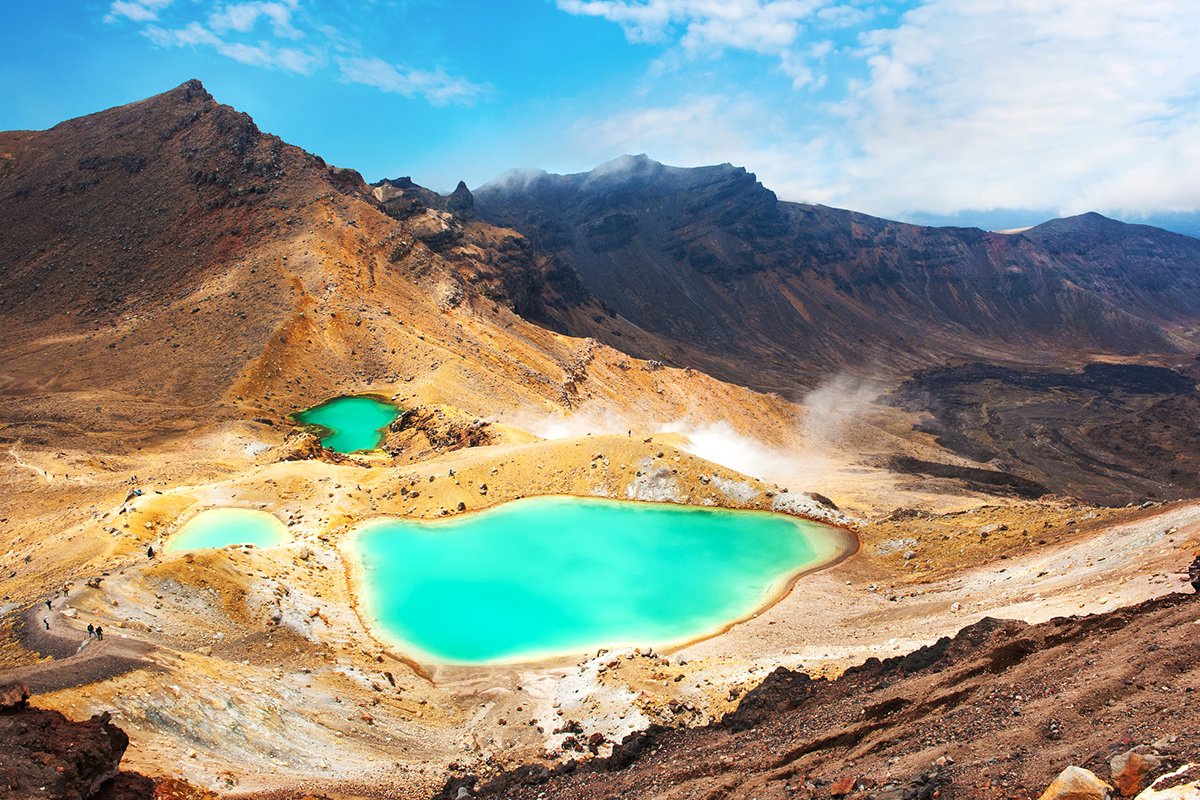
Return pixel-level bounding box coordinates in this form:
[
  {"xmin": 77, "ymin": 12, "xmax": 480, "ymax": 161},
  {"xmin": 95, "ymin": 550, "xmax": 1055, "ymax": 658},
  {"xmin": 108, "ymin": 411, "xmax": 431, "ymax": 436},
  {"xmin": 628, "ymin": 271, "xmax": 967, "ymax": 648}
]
[{"xmin": 889, "ymin": 363, "xmax": 1200, "ymax": 505}]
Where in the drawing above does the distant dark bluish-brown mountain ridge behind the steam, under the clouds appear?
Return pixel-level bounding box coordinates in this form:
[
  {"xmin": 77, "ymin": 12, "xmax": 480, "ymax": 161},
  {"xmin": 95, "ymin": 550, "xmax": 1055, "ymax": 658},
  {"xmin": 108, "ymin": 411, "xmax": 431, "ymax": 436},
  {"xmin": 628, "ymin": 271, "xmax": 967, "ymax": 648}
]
[{"xmin": 475, "ymin": 156, "xmax": 1200, "ymax": 391}]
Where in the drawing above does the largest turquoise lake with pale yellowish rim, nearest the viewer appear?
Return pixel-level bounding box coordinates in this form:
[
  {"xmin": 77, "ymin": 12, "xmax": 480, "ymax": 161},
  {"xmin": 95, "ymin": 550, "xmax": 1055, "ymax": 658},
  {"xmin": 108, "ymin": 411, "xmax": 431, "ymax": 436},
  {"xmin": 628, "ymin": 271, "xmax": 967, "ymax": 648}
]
[{"xmin": 356, "ymin": 498, "xmax": 848, "ymax": 663}]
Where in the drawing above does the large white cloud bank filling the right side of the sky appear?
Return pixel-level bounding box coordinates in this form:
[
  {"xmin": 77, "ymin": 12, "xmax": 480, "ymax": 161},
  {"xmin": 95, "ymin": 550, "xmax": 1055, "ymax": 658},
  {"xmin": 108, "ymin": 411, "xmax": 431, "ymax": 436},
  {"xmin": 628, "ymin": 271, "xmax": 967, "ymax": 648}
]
[{"xmin": 558, "ymin": 0, "xmax": 1200, "ymax": 217}]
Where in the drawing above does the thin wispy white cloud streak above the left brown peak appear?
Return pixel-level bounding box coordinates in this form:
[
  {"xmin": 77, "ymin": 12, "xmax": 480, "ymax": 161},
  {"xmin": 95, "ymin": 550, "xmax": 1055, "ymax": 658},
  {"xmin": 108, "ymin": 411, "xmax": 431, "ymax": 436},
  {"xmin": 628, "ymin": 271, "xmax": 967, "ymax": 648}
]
[{"xmin": 104, "ymin": 0, "xmax": 485, "ymax": 106}]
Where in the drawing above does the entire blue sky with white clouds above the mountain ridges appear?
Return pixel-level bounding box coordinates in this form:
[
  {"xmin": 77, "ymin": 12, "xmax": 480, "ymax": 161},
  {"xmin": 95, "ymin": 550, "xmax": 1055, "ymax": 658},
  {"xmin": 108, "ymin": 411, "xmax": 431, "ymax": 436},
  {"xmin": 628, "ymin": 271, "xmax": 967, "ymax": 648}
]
[{"xmin": 0, "ymin": 0, "xmax": 1200, "ymax": 222}]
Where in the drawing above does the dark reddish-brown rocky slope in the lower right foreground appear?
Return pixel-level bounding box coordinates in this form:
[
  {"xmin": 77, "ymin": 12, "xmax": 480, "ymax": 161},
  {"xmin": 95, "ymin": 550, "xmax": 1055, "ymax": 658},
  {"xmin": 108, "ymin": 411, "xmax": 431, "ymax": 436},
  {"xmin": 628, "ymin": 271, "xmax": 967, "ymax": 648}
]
[{"xmin": 438, "ymin": 575, "xmax": 1200, "ymax": 800}]
